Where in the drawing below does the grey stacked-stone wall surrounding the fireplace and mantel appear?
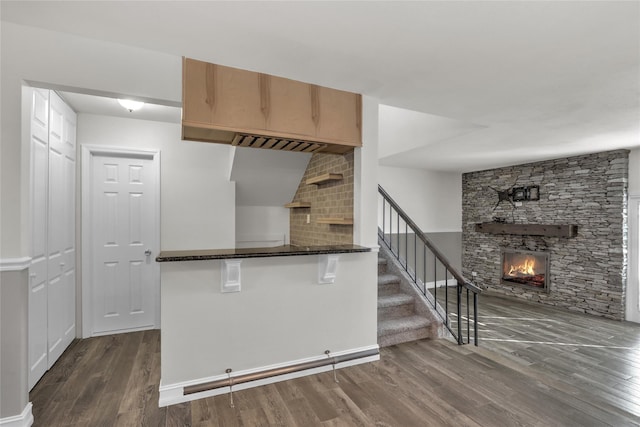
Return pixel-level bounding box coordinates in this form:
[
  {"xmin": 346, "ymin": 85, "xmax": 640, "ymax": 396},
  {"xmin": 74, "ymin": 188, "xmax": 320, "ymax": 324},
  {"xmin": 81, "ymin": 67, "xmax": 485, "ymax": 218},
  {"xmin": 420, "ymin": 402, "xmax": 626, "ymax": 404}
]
[{"xmin": 462, "ymin": 150, "xmax": 629, "ymax": 320}]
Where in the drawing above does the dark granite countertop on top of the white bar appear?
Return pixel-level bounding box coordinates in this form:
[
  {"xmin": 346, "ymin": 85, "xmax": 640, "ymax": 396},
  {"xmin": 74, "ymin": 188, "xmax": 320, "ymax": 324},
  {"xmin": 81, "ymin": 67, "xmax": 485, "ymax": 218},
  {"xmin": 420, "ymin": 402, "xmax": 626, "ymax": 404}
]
[{"xmin": 156, "ymin": 245, "xmax": 371, "ymax": 262}]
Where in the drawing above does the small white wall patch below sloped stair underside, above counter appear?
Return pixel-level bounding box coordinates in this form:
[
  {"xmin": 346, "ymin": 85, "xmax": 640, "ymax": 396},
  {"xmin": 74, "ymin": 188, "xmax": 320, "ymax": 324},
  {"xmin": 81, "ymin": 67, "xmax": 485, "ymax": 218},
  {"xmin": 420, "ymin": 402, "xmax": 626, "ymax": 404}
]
[{"xmin": 235, "ymin": 206, "xmax": 289, "ymax": 248}]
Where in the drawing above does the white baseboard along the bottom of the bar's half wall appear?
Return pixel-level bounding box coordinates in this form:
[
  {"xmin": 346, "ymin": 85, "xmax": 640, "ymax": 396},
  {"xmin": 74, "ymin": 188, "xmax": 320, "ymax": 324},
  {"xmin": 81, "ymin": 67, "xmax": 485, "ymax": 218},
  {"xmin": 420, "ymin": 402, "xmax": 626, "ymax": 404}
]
[{"xmin": 158, "ymin": 344, "xmax": 380, "ymax": 407}]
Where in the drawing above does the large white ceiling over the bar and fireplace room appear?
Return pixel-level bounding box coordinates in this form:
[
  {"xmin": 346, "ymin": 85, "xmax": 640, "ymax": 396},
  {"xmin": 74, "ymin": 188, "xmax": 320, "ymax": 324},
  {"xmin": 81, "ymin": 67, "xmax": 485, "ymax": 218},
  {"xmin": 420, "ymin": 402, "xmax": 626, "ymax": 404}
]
[{"xmin": 1, "ymin": 0, "xmax": 640, "ymax": 171}]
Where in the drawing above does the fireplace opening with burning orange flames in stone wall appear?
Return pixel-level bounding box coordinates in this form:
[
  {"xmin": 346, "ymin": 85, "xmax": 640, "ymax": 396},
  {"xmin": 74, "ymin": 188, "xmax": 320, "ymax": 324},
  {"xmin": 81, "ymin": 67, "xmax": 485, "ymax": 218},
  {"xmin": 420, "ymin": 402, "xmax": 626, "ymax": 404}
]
[{"xmin": 501, "ymin": 249, "xmax": 549, "ymax": 291}]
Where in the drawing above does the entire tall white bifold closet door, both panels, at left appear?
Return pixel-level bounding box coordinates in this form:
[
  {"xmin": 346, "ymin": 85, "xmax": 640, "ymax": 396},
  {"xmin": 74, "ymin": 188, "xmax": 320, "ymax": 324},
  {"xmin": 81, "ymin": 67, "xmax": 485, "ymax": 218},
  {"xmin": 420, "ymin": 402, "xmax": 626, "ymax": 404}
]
[{"xmin": 29, "ymin": 88, "xmax": 76, "ymax": 389}]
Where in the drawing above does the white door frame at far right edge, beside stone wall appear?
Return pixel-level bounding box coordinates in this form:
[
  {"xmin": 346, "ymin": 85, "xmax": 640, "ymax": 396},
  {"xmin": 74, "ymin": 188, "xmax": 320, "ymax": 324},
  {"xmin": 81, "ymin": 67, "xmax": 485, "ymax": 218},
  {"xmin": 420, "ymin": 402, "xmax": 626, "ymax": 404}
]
[{"xmin": 625, "ymin": 196, "xmax": 640, "ymax": 323}]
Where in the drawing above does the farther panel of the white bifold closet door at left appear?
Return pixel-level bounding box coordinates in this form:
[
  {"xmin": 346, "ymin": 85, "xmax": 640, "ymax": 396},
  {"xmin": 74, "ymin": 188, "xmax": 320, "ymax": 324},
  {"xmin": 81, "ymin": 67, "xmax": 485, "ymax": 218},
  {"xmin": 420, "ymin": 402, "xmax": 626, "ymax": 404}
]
[{"xmin": 47, "ymin": 92, "xmax": 76, "ymax": 368}]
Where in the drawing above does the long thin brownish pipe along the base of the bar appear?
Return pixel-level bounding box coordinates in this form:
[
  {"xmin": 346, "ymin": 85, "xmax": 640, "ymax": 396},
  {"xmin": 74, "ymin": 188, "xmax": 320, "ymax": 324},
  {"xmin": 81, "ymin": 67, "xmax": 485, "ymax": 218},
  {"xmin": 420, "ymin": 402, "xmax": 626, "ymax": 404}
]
[{"xmin": 182, "ymin": 349, "xmax": 380, "ymax": 395}]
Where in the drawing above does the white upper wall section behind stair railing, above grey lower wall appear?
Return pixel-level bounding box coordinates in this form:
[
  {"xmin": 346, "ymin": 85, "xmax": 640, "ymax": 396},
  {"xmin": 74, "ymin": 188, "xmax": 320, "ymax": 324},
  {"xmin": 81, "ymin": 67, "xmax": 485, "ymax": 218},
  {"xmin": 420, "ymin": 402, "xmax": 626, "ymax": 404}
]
[{"xmin": 378, "ymin": 166, "xmax": 462, "ymax": 233}]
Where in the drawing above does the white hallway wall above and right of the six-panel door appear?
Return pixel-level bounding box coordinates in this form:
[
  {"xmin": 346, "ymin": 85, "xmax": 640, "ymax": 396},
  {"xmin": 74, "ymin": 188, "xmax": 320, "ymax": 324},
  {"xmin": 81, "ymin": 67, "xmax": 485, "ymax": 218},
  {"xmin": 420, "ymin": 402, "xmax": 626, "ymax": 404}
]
[{"xmin": 78, "ymin": 114, "xmax": 235, "ymax": 250}]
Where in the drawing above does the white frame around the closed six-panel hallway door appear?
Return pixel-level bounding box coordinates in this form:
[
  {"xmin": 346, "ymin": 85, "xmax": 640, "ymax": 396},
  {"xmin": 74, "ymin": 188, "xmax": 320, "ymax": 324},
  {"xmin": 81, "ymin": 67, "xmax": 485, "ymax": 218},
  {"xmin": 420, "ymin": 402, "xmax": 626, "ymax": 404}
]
[{"xmin": 81, "ymin": 145, "xmax": 160, "ymax": 338}]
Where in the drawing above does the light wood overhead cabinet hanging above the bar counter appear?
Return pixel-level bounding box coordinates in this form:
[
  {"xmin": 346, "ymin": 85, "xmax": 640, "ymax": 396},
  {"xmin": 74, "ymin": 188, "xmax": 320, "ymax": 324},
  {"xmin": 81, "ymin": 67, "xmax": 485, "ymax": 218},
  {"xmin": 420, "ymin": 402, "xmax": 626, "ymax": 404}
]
[{"xmin": 182, "ymin": 58, "xmax": 362, "ymax": 153}]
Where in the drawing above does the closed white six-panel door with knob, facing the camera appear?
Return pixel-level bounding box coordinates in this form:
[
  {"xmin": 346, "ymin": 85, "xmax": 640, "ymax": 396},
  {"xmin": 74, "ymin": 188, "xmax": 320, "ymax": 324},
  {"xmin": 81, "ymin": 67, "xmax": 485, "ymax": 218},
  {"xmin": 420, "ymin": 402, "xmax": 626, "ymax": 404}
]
[{"xmin": 89, "ymin": 152, "xmax": 160, "ymax": 335}]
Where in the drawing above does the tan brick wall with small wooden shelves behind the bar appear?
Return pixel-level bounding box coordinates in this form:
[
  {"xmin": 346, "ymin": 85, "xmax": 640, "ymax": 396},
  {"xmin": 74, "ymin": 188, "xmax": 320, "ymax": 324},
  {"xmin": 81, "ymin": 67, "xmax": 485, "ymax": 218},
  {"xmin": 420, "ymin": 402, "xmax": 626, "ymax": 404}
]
[{"xmin": 289, "ymin": 151, "xmax": 353, "ymax": 246}]
